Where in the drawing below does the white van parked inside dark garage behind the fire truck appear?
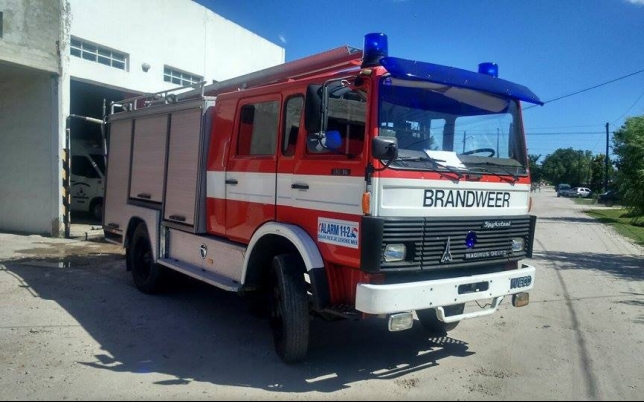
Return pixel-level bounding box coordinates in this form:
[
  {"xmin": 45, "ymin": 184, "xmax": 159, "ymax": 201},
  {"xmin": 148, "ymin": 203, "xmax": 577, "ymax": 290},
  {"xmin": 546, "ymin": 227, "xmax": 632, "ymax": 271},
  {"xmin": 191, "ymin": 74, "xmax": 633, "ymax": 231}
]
[{"xmin": 70, "ymin": 141, "xmax": 105, "ymax": 220}]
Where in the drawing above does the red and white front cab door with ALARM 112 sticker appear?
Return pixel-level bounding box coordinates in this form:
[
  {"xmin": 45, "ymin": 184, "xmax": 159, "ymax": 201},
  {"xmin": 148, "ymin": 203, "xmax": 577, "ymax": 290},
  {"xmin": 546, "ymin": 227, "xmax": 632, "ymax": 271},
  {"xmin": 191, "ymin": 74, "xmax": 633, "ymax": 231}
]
[{"xmin": 278, "ymin": 89, "xmax": 367, "ymax": 266}]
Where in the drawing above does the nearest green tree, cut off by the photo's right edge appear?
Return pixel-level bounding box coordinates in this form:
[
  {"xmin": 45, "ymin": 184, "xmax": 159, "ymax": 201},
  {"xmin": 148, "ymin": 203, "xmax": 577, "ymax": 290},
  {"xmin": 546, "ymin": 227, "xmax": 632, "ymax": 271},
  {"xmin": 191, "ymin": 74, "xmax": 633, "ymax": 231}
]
[{"xmin": 613, "ymin": 116, "xmax": 644, "ymax": 215}]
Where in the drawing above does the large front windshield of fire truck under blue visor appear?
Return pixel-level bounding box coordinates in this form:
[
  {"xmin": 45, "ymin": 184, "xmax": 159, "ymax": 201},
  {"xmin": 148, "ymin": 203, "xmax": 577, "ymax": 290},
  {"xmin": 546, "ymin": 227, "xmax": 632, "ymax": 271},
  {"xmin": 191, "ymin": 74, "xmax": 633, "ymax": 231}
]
[{"xmin": 379, "ymin": 77, "xmax": 527, "ymax": 175}]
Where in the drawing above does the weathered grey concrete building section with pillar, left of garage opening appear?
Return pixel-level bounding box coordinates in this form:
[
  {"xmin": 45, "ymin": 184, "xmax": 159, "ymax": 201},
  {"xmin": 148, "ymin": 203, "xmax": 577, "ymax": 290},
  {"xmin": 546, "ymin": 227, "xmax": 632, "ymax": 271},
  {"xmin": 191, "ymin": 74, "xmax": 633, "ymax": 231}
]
[{"xmin": 0, "ymin": 0, "xmax": 69, "ymax": 236}]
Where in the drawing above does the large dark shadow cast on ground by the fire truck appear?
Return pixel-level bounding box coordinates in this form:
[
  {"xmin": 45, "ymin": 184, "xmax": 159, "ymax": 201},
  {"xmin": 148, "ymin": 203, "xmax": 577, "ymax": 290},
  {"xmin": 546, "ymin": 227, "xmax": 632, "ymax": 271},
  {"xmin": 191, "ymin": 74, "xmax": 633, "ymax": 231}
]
[{"xmin": 0, "ymin": 255, "xmax": 474, "ymax": 393}]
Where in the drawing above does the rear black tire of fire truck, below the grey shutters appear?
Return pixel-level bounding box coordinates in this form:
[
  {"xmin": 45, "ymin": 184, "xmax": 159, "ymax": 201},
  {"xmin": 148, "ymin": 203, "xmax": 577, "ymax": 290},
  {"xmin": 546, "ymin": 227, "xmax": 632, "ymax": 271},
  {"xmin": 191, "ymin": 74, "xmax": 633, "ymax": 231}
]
[{"xmin": 125, "ymin": 223, "xmax": 165, "ymax": 294}]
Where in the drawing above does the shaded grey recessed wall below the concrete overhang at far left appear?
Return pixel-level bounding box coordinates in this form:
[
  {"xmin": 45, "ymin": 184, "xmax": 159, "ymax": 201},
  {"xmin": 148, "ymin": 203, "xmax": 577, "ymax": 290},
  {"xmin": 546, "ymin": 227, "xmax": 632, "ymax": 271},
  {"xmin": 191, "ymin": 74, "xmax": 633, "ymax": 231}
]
[{"xmin": 0, "ymin": 68, "xmax": 60, "ymax": 235}]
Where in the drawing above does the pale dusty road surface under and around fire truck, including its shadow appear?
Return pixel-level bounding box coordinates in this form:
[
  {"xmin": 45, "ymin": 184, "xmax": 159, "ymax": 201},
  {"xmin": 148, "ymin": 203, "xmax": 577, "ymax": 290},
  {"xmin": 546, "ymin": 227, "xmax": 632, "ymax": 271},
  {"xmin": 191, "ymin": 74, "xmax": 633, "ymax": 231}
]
[{"xmin": 0, "ymin": 190, "xmax": 644, "ymax": 400}]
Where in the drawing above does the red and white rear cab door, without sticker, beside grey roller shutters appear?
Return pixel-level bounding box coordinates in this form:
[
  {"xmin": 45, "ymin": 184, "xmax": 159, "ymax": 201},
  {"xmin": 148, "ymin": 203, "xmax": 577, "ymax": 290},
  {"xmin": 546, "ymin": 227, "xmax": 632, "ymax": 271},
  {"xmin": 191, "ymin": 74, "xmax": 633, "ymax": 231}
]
[{"xmin": 225, "ymin": 95, "xmax": 280, "ymax": 242}]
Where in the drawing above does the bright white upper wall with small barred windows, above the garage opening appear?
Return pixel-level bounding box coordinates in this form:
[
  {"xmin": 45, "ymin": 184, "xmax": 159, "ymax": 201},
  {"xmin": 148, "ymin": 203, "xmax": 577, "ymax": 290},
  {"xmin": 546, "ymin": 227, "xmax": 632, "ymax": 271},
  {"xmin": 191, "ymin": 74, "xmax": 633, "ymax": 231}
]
[{"xmin": 67, "ymin": 0, "xmax": 285, "ymax": 92}]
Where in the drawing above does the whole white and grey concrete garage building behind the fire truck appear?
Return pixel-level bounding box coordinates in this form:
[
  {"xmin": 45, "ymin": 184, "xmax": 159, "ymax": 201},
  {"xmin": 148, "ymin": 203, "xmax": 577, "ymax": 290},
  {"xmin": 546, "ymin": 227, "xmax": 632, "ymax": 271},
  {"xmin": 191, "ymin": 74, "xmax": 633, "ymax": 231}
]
[{"xmin": 0, "ymin": 0, "xmax": 285, "ymax": 236}]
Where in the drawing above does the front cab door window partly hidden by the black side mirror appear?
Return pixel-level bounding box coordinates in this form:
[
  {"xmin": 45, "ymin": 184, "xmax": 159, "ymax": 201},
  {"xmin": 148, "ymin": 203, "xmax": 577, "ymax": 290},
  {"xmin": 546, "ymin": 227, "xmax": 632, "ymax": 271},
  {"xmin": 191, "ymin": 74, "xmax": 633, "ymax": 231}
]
[{"xmin": 307, "ymin": 88, "xmax": 367, "ymax": 155}]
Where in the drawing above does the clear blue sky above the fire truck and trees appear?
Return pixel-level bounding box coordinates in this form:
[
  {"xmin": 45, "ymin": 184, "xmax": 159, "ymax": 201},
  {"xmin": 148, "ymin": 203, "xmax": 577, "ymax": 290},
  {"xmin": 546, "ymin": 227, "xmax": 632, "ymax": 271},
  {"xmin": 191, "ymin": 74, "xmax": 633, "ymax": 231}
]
[{"xmin": 196, "ymin": 0, "xmax": 644, "ymax": 162}]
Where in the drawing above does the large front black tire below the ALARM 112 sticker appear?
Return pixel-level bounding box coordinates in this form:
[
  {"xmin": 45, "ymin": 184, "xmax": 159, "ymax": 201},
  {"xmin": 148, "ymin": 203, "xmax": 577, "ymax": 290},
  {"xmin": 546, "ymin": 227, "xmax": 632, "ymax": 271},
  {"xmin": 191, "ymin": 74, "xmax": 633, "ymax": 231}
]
[{"xmin": 271, "ymin": 254, "xmax": 309, "ymax": 363}]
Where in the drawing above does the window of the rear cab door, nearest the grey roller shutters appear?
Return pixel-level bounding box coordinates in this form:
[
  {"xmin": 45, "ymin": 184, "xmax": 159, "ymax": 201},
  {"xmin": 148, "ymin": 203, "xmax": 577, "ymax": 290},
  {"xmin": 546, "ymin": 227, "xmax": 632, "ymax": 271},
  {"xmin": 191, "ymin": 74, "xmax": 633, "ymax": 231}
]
[{"xmin": 237, "ymin": 101, "xmax": 279, "ymax": 156}]
